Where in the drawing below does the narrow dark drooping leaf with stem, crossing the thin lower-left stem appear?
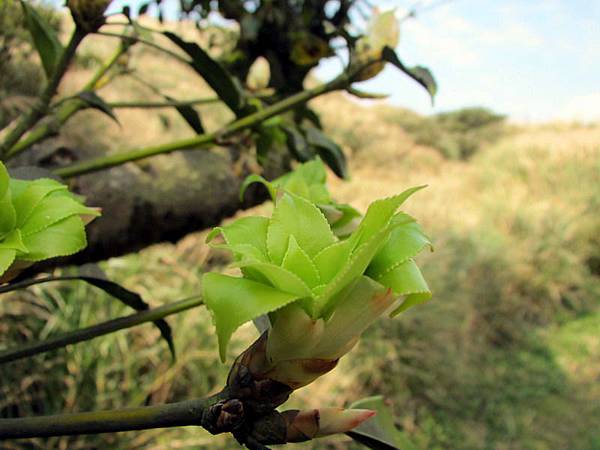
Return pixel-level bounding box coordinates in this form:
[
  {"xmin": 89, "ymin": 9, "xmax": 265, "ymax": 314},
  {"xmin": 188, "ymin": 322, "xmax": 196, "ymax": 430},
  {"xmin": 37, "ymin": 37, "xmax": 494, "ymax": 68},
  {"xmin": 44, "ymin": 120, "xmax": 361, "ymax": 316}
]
[{"xmin": 0, "ymin": 272, "xmax": 175, "ymax": 360}]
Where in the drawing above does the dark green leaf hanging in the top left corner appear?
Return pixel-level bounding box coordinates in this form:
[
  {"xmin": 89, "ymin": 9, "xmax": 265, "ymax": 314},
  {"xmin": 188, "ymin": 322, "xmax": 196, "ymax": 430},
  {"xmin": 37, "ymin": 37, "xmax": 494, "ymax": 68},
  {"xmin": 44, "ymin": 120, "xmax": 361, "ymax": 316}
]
[{"xmin": 21, "ymin": 0, "xmax": 63, "ymax": 79}]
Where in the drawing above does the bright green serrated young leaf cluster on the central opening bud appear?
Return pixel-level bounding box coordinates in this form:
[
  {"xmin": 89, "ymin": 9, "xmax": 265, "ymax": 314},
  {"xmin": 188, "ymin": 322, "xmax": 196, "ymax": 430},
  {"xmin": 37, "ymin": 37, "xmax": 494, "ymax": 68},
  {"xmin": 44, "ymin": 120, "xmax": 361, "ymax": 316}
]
[{"xmin": 203, "ymin": 160, "xmax": 431, "ymax": 359}]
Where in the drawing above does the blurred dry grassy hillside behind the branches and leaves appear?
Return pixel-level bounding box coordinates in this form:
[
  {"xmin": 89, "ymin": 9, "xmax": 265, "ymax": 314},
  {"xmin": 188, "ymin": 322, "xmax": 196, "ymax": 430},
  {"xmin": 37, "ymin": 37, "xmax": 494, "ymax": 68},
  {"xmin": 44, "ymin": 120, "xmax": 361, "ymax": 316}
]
[{"xmin": 0, "ymin": 20, "xmax": 600, "ymax": 450}]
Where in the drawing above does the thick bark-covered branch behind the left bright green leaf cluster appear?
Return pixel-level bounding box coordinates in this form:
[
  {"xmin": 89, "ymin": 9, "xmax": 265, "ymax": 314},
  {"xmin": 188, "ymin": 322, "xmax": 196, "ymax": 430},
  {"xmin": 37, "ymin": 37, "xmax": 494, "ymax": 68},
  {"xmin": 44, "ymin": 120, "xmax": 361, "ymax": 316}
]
[{"xmin": 11, "ymin": 142, "xmax": 289, "ymax": 271}]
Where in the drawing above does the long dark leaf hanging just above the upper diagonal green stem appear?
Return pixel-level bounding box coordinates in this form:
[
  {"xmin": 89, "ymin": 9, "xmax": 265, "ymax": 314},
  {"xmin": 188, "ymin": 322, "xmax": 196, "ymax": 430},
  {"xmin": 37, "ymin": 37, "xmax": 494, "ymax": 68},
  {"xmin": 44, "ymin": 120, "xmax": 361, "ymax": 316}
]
[{"xmin": 163, "ymin": 31, "xmax": 243, "ymax": 115}]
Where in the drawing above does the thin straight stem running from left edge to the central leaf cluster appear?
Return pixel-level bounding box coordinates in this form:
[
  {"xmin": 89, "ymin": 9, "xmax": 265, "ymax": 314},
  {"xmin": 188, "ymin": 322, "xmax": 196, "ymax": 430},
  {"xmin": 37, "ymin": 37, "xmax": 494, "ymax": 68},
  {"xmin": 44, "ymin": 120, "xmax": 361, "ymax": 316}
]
[{"xmin": 0, "ymin": 296, "xmax": 204, "ymax": 366}]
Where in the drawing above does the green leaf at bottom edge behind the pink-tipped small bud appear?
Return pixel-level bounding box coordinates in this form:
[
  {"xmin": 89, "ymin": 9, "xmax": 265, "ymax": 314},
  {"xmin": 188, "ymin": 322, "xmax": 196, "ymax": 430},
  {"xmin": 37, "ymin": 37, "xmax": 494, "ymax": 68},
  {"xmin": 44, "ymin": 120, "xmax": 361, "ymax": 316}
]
[{"xmin": 346, "ymin": 395, "xmax": 417, "ymax": 450}]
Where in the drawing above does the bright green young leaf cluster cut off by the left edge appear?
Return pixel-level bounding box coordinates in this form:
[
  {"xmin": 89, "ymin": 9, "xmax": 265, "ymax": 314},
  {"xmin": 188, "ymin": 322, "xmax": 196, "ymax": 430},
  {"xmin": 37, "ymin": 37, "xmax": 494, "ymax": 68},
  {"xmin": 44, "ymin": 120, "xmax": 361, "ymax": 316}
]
[{"xmin": 0, "ymin": 162, "xmax": 100, "ymax": 281}]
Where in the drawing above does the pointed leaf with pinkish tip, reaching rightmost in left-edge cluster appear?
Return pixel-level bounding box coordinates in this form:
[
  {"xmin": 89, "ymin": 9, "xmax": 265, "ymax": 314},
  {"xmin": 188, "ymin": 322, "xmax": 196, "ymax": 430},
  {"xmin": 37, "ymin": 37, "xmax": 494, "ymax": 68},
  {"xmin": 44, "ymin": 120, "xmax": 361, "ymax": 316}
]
[{"xmin": 21, "ymin": 195, "xmax": 100, "ymax": 236}]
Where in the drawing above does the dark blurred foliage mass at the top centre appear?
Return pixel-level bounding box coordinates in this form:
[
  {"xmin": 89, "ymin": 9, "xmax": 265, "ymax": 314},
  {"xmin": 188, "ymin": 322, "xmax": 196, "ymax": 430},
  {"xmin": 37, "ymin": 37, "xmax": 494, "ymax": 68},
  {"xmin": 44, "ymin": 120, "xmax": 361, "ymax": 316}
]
[{"xmin": 173, "ymin": 0, "xmax": 358, "ymax": 94}]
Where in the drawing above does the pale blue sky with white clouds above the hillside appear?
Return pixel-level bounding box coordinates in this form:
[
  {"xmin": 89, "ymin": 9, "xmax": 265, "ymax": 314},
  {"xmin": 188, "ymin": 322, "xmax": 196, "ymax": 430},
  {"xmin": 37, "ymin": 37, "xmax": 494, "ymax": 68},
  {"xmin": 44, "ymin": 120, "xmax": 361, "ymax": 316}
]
[{"xmin": 95, "ymin": 0, "xmax": 600, "ymax": 121}]
